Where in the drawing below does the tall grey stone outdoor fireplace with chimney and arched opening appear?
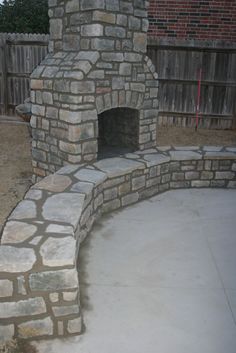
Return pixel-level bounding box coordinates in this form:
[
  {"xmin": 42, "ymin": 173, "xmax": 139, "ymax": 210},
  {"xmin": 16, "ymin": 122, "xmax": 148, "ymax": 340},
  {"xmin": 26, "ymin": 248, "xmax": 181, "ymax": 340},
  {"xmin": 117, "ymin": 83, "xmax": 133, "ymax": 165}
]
[{"xmin": 31, "ymin": 0, "xmax": 158, "ymax": 178}]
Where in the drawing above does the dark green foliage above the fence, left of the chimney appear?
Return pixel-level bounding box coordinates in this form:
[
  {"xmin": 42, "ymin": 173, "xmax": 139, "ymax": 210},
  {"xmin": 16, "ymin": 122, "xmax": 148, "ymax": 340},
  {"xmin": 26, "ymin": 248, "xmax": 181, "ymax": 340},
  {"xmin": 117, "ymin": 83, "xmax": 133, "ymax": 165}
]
[{"xmin": 0, "ymin": 0, "xmax": 49, "ymax": 33}]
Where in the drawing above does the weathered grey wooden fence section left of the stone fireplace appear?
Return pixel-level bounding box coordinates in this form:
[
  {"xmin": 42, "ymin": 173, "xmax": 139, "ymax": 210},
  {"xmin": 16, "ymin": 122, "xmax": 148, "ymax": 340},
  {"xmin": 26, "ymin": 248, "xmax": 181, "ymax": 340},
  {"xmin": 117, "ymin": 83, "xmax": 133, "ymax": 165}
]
[{"xmin": 0, "ymin": 33, "xmax": 49, "ymax": 115}]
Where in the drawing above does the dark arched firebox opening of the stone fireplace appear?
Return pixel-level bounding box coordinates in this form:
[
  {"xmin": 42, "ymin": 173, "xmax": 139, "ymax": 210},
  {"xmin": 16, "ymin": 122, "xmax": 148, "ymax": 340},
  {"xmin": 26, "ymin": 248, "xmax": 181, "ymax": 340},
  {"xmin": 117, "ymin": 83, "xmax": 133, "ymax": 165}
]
[{"xmin": 98, "ymin": 108, "xmax": 139, "ymax": 159}]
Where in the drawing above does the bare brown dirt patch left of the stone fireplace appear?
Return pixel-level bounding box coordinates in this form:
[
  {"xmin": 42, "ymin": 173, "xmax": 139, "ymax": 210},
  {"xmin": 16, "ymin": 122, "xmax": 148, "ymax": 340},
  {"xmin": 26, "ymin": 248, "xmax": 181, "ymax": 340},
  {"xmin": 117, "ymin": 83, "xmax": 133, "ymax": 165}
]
[{"xmin": 0, "ymin": 124, "xmax": 32, "ymax": 229}]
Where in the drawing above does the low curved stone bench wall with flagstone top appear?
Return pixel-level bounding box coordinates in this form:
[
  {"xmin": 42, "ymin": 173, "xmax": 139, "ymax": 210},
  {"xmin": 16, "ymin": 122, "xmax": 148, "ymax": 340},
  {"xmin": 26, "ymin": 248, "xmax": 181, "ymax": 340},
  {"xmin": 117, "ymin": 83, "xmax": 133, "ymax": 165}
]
[{"xmin": 0, "ymin": 147, "xmax": 236, "ymax": 340}]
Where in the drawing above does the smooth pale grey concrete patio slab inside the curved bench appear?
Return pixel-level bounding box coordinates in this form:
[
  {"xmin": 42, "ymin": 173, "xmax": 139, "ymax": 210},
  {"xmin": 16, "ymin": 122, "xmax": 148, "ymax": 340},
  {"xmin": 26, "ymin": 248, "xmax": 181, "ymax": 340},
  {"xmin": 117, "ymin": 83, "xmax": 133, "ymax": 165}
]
[{"xmin": 36, "ymin": 189, "xmax": 236, "ymax": 353}]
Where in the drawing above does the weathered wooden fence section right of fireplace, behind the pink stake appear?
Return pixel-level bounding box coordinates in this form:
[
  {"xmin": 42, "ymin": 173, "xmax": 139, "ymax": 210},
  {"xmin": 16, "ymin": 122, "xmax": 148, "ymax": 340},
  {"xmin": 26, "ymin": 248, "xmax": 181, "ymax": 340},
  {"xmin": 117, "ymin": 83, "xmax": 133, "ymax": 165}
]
[{"xmin": 148, "ymin": 38, "xmax": 236, "ymax": 129}]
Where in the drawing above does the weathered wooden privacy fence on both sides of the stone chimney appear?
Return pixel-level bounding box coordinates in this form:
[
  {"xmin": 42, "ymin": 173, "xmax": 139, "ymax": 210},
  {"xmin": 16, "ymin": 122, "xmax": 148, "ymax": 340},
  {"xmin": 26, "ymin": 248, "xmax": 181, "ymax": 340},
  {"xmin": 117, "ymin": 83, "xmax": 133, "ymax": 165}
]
[{"xmin": 0, "ymin": 33, "xmax": 236, "ymax": 129}]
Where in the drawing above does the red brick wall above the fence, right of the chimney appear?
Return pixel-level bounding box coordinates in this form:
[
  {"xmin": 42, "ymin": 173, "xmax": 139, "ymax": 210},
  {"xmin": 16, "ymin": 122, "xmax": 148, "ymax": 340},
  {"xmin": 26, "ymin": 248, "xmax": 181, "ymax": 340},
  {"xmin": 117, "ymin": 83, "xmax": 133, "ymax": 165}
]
[{"xmin": 149, "ymin": 0, "xmax": 236, "ymax": 41}]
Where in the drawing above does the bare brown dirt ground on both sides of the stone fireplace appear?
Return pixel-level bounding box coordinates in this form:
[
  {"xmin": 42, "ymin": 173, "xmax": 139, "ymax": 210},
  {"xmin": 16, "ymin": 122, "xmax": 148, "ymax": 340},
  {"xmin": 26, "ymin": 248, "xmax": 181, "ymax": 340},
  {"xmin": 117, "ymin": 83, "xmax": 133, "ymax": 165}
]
[{"xmin": 0, "ymin": 124, "xmax": 236, "ymax": 229}]
